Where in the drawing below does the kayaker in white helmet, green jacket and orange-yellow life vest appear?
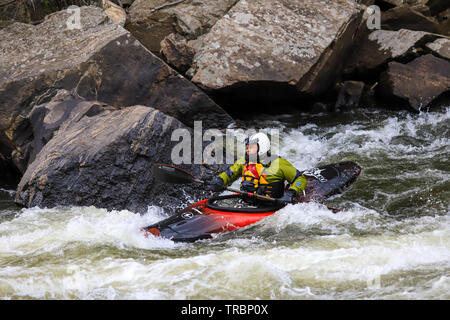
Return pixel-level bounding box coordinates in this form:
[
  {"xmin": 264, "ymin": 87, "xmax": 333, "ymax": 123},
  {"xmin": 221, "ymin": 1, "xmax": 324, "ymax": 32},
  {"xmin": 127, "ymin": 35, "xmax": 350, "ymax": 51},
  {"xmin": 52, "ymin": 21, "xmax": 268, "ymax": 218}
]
[{"xmin": 207, "ymin": 132, "xmax": 307, "ymax": 204}]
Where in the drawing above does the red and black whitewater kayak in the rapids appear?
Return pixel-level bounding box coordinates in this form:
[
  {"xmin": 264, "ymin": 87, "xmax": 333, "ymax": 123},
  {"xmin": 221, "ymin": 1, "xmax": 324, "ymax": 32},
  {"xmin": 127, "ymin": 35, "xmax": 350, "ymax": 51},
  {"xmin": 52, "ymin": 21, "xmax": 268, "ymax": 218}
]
[{"xmin": 143, "ymin": 162, "xmax": 361, "ymax": 242}]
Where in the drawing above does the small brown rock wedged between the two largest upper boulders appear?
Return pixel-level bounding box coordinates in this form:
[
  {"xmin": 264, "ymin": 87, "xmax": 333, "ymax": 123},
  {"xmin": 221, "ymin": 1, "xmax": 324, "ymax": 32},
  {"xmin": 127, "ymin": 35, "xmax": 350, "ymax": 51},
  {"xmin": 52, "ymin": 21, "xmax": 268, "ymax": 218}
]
[{"xmin": 161, "ymin": 33, "xmax": 195, "ymax": 73}]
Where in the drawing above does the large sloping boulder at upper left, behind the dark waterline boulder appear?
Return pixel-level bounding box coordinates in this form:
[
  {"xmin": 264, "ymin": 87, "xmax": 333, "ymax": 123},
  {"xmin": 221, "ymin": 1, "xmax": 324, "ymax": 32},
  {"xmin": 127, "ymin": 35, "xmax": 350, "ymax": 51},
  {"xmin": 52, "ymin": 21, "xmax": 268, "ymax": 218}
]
[{"xmin": 0, "ymin": 7, "xmax": 232, "ymax": 178}]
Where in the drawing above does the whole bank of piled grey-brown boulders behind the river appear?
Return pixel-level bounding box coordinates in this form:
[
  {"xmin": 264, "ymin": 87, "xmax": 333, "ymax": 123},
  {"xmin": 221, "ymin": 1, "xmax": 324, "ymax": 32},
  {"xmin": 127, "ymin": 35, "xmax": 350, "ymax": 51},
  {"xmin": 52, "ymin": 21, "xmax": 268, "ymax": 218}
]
[{"xmin": 0, "ymin": 0, "xmax": 450, "ymax": 212}]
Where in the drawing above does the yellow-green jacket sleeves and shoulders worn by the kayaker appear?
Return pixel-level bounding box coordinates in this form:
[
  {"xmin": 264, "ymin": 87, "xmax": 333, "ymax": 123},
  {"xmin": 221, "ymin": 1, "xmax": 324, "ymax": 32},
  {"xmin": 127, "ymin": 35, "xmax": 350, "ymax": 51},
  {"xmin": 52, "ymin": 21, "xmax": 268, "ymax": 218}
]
[{"xmin": 219, "ymin": 157, "xmax": 307, "ymax": 198}]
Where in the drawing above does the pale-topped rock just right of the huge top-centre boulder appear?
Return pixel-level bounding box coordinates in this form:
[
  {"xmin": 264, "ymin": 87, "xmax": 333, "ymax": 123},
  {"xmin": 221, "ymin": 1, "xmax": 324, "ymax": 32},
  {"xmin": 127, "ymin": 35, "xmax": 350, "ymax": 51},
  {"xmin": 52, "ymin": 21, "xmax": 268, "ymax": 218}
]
[{"xmin": 344, "ymin": 29, "xmax": 437, "ymax": 75}]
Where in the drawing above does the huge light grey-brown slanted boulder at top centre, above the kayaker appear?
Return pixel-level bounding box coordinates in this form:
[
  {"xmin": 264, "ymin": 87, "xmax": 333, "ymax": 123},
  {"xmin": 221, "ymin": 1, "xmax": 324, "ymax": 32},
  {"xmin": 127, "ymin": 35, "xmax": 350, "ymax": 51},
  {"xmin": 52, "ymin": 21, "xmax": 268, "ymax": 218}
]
[{"xmin": 189, "ymin": 0, "xmax": 361, "ymax": 94}]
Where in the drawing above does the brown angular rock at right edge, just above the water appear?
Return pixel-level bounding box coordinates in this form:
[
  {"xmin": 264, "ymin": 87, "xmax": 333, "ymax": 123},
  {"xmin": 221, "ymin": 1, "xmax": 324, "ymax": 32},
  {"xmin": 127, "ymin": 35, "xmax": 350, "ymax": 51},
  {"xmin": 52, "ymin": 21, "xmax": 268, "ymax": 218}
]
[{"xmin": 380, "ymin": 54, "xmax": 450, "ymax": 111}]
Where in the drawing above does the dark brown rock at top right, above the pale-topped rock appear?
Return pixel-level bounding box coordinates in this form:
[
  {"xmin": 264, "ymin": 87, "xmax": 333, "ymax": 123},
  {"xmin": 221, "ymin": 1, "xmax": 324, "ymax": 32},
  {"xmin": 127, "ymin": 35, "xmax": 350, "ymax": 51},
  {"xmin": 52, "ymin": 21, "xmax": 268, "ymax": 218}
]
[{"xmin": 381, "ymin": 5, "xmax": 440, "ymax": 33}]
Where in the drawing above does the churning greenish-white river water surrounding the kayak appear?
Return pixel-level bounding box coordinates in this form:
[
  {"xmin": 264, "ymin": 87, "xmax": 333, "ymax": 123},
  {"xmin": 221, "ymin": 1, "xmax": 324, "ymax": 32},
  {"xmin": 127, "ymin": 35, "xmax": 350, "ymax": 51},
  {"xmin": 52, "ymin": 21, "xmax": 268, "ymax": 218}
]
[{"xmin": 0, "ymin": 108, "xmax": 450, "ymax": 300}]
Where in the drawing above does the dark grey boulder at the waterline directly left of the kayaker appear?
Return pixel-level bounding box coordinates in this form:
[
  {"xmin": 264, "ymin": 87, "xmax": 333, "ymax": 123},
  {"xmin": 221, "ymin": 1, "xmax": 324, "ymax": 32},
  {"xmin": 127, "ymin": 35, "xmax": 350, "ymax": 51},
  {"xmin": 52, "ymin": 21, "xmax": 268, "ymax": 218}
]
[{"xmin": 15, "ymin": 101, "xmax": 221, "ymax": 212}]
